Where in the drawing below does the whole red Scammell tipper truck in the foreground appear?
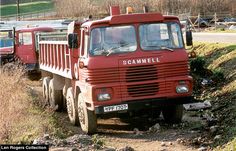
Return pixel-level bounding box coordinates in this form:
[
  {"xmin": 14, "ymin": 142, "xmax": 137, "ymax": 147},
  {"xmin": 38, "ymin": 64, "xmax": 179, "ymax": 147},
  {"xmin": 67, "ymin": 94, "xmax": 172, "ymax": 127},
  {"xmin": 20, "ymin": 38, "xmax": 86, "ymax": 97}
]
[{"xmin": 39, "ymin": 7, "xmax": 193, "ymax": 133}]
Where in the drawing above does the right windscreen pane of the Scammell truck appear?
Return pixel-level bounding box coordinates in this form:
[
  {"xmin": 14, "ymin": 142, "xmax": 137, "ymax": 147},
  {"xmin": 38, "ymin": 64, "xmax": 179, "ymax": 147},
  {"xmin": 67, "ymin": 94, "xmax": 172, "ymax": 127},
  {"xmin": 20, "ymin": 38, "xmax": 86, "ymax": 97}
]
[{"xmin": 139, "ymin": 23, "xmax": 183, "ymax": 51}]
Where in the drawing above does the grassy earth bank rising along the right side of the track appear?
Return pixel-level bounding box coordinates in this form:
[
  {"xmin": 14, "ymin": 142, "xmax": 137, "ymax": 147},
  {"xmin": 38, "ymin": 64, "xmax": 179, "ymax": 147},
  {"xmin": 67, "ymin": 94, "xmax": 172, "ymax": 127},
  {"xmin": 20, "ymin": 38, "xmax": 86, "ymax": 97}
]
[{"xmin": 192, "ymin": 43, "xmax": 236, "ymax": 151}]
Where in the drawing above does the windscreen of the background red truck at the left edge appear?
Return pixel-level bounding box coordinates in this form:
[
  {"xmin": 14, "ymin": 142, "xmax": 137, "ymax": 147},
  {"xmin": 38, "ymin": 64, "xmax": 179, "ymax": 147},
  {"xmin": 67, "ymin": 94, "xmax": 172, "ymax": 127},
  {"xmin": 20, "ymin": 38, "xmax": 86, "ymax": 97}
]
[{"xmin": 0, "ymin": 31, "xmax": 13, "ymax": 48}]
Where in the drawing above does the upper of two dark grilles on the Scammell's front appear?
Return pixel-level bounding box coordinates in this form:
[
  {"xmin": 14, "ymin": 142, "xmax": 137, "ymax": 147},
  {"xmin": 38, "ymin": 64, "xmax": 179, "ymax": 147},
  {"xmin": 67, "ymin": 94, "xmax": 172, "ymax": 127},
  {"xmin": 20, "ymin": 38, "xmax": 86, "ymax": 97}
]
[{"xmin": 125, "ymin": 65, "xmax": 157, "ymax": 82}]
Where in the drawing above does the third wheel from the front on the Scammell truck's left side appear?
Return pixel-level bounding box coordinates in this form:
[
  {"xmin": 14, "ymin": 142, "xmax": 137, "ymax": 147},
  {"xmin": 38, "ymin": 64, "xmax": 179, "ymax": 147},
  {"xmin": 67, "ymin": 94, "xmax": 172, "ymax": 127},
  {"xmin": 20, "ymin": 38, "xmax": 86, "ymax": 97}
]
[{"xmin": 49, "ymin": 79, "xmax": 63, "ymax": 111}]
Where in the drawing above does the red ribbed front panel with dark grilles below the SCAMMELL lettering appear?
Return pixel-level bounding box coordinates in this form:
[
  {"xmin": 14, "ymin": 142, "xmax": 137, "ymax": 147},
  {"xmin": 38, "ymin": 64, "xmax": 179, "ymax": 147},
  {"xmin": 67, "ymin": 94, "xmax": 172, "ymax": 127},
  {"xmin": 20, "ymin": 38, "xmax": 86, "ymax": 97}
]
[{"xmin": 82, "ymin": 61, "xmax": 189, "ymax": 99}]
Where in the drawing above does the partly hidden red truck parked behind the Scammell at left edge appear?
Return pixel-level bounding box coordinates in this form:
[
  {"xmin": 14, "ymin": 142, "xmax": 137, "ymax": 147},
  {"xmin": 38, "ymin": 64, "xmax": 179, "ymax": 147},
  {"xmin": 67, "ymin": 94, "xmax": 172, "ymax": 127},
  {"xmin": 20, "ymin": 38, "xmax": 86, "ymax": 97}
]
[{"xmin": 0, "ymin": 27, "xmax": 54, "ymax": 71}]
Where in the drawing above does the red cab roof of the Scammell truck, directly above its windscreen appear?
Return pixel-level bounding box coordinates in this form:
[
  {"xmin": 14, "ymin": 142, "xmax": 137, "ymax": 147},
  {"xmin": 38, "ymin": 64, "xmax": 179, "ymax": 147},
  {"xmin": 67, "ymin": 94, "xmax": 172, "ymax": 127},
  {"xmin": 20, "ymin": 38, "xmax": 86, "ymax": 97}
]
[{"xmin": 82, "ymin": 13, "xmax": 179, "ymax": 27}]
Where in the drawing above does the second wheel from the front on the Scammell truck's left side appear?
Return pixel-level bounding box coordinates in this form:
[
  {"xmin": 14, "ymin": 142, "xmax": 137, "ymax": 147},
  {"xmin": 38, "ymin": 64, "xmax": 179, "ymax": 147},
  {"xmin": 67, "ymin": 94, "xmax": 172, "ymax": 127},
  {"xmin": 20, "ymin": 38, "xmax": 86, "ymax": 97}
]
[{"xmin": 66, "ymin": 87, "xmax": 79, "ymax": 125}]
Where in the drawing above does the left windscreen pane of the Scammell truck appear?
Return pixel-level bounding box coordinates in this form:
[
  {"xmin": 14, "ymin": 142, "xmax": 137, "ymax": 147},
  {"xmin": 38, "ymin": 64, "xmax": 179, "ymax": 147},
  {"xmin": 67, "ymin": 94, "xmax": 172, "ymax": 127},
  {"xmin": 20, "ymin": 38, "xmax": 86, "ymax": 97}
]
[{"xmin": 89, "ymin": 26, "xmax": 137, "ymax": 56}]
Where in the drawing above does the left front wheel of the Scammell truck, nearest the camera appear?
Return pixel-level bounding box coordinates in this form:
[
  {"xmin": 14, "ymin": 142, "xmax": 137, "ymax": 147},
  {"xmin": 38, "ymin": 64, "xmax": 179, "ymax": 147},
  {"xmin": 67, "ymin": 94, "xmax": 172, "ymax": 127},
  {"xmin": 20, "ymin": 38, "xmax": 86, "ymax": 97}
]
[{"xmin": 78, "ymin": 94, "xmax": 97, "ymax": 134}]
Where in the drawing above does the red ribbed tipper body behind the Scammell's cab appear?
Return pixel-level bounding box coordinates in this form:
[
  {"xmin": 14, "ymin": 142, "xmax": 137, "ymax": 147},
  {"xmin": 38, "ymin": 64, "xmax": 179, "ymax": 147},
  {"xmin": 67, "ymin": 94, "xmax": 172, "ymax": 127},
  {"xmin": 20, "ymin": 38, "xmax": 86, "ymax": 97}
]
[{"xmin": 38, "ymin": 33, "xmax": 73, "ymax": 79}]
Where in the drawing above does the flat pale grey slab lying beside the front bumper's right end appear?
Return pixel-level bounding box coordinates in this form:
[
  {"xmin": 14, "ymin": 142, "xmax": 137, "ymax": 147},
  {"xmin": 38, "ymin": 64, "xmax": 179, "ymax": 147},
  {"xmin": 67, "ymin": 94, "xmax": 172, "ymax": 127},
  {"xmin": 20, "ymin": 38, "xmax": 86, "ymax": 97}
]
[{"xmin": 183, "ymin": 101, "xmax": 211, "ymax": 111}]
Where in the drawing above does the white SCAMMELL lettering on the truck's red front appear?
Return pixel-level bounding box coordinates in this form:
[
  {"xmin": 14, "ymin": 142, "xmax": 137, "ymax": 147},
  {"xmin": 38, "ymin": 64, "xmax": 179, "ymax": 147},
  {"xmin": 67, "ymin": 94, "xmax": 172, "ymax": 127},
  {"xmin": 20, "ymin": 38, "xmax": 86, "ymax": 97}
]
[{"xmin": 123, "ymin": 58, "xmax": 160, "ymax": 65}]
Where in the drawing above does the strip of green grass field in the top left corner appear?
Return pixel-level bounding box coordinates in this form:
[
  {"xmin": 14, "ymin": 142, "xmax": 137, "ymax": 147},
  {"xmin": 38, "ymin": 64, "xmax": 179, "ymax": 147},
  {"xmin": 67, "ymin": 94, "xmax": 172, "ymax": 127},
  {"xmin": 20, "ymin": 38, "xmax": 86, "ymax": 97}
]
[{"xmin": 0, "ymin": 1, "xmax": 54, "ymax": 16}]
